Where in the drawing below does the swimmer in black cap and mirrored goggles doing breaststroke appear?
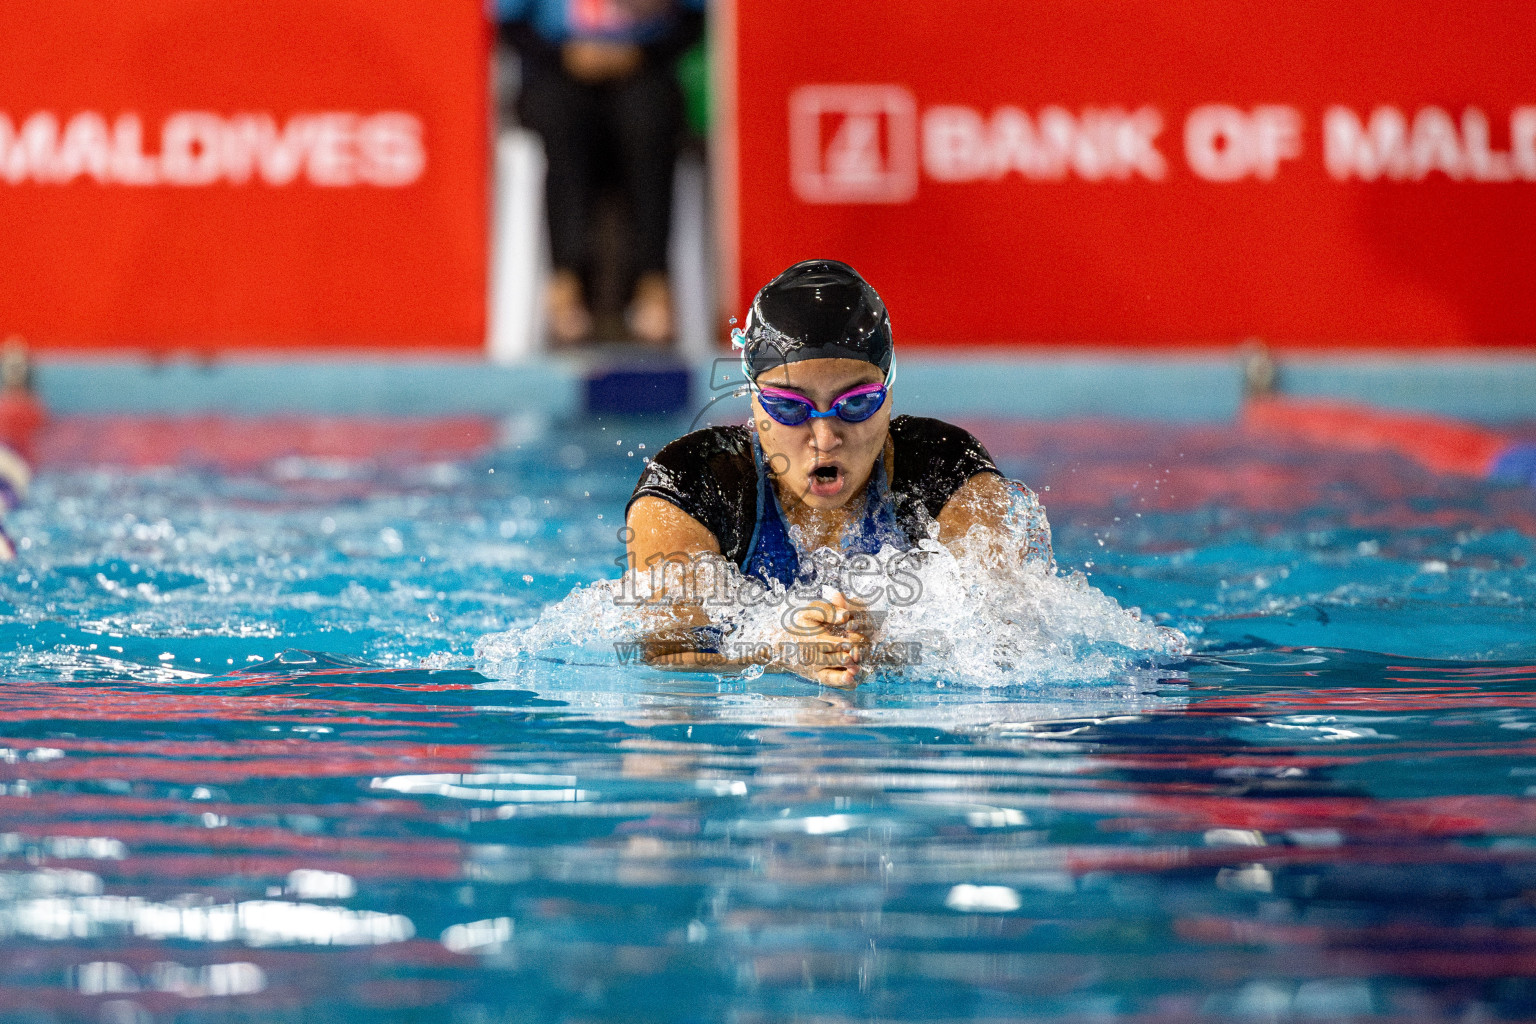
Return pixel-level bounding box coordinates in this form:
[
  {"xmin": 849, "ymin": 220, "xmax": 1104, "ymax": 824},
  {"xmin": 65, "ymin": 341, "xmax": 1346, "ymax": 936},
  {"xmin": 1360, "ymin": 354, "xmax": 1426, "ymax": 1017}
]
[{"xmin": 625, "ymin": 259, "xmax": 1028, "ymax": 689}]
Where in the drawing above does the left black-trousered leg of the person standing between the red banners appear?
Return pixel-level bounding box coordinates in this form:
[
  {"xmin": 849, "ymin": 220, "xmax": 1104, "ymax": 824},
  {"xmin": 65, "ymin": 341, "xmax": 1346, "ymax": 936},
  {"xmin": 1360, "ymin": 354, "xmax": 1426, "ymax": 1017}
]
[{"xmin": 518, "ymin": 61, "xmax": 602, "ymax": 344}]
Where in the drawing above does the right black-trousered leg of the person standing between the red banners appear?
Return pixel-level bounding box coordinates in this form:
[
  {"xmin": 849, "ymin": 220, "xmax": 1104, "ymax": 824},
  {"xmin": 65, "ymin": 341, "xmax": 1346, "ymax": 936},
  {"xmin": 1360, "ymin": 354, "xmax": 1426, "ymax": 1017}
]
[{"xmin": 608, "ymin": 64, "xmax": 682, "ymax": 344}]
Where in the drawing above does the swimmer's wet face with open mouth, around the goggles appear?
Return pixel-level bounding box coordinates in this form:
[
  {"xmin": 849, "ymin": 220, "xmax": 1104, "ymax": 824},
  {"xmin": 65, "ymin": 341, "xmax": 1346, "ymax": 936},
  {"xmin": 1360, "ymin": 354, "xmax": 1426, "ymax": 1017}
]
[{"xmin": 753, "ymin": 359, "xmax": 891, "ymax": 508}]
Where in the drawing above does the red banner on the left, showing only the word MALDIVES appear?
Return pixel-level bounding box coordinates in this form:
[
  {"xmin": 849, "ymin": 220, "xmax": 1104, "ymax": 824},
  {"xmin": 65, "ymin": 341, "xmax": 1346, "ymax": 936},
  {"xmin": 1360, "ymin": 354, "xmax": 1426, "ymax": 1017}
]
[{"xmin": 0, "ymin": 0, "xmax": 488, "ymax": 352}]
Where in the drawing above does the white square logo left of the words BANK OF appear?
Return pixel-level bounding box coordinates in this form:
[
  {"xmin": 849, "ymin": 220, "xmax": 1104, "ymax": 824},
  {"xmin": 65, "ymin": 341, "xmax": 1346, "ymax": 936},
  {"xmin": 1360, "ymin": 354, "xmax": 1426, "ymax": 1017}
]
[{"xmin": 790, "ymin": 86, "xmax": 917, "ymax": 203}]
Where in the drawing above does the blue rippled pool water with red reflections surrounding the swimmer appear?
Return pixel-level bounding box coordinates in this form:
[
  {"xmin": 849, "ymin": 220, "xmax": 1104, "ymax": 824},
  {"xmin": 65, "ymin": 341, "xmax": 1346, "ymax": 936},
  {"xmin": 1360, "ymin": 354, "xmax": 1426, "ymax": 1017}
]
[{"xmin": 0, "ymin": 421, "xmax": 1536, "ymax": 1024}]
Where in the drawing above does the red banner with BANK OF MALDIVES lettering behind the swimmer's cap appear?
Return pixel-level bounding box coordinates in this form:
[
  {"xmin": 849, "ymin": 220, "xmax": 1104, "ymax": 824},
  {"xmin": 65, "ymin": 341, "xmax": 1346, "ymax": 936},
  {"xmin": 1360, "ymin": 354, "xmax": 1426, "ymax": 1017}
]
[{"xmin": 725, "ymin": 0, "xmax": 1536, "ymax": 345}]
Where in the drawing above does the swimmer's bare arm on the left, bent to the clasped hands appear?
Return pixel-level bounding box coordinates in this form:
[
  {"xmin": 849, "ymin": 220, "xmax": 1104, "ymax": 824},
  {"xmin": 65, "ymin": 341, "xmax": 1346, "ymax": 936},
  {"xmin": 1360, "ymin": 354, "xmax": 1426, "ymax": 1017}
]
[{"xmin": 628, "ymin": 494, "xmax": 865, "ymax": 689}]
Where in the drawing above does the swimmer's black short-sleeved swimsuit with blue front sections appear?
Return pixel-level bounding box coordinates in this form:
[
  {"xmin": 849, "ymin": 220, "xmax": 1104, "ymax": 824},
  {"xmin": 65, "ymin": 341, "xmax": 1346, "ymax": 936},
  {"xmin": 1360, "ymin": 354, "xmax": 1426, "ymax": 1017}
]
[{"xmin": 630, "ymin": 416, "xmax": 998, "ymax": 585}]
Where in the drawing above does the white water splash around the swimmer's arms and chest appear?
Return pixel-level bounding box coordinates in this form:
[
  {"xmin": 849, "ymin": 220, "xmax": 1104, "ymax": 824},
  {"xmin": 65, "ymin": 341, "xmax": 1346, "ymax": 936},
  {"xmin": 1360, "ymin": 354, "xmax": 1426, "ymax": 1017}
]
[{"xmin": 475, "ymin": 485, "xmax": 1189, "ymax": 686}]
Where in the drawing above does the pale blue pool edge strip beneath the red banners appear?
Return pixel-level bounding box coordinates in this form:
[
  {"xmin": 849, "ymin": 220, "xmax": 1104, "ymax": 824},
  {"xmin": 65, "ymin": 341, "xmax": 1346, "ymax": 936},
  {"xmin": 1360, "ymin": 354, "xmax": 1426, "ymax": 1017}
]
[{"xmin": 37, "ymin": 352, "xmax": 1536, "ymax": 422}]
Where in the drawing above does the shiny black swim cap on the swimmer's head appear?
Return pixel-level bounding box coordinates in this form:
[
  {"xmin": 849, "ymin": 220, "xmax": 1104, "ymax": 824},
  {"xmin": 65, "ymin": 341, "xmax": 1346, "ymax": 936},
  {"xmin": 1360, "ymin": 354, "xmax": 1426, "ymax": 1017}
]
[{"xmin": 736, "ymin": 259, "xmax": 894, "ymax": 378}]
